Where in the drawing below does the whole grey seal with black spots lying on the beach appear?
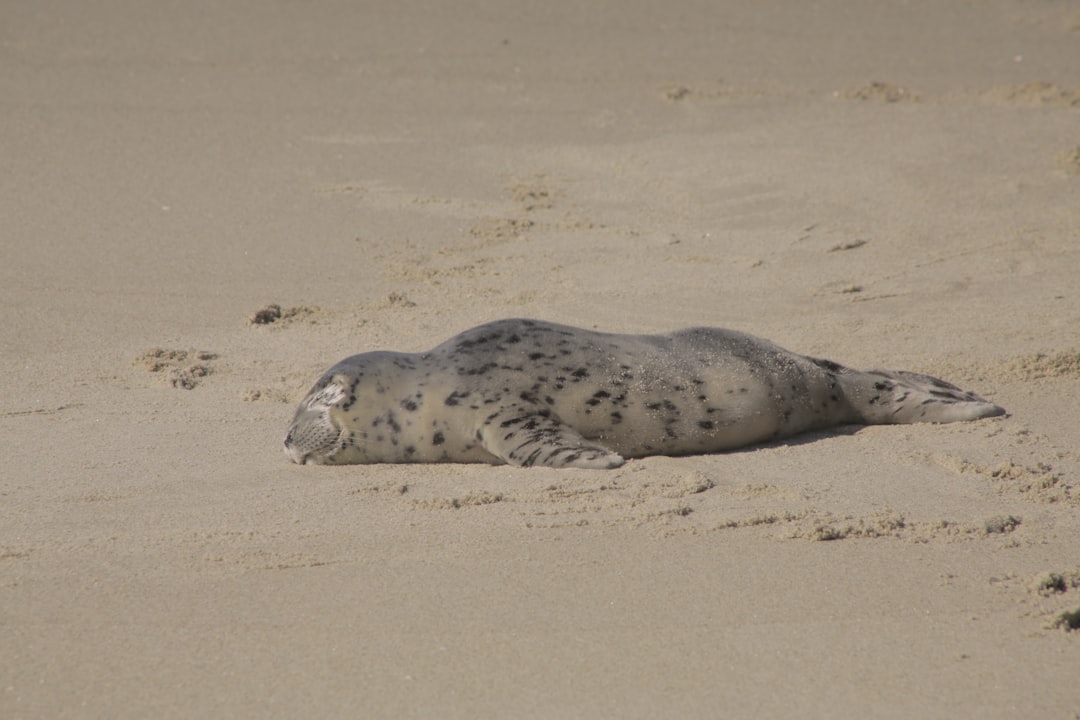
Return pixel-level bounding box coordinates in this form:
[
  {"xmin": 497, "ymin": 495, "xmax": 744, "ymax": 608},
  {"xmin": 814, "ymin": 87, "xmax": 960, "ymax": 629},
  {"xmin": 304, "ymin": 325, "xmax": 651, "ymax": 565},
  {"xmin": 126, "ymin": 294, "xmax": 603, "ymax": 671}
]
[{"xmin": 285, "ymin": 320, "xmax": 1004, "ymax": 468}]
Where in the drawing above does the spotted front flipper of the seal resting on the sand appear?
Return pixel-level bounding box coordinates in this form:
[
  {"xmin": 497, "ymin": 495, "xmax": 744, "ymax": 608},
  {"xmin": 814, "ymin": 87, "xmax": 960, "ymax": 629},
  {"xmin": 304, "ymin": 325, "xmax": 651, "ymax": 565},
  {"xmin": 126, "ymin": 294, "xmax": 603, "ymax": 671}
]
[{"xmin": 477, "ymin": 405, "xmax": 625, "ymax": 470}]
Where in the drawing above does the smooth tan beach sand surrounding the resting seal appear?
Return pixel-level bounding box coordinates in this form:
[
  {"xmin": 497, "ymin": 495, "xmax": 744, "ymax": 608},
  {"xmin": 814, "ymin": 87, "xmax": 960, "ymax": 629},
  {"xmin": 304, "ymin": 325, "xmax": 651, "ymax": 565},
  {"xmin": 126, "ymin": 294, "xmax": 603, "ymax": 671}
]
[{"xmin": 0, "ymin": 0, "xmax": 1080, "ymax": 719}]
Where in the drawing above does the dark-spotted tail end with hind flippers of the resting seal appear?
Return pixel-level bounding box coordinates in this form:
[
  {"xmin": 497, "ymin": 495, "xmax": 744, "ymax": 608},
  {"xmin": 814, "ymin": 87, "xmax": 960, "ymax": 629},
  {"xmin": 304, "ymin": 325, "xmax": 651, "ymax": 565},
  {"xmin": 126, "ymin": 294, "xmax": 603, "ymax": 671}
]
[{"xmin": 837, "ymin": 370, "xmax": 1005, "ymax": 425}]
